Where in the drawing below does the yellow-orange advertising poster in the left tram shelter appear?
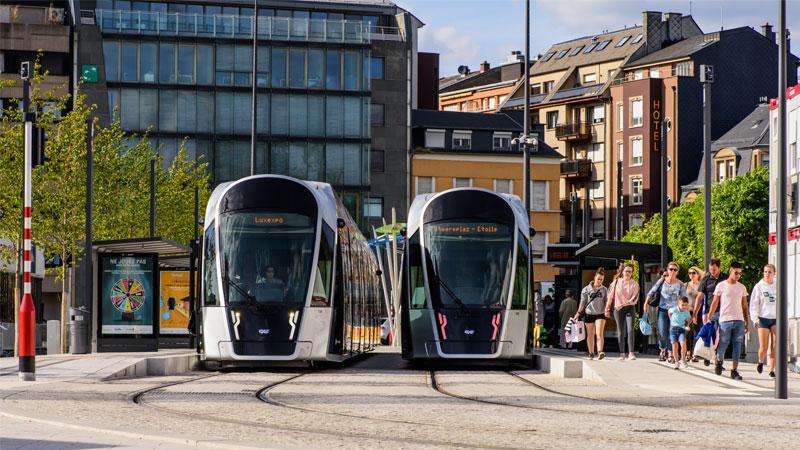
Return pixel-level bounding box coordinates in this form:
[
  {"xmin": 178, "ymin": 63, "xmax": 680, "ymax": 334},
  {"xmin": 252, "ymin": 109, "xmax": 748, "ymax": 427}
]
[{"xmin": 159, "ymin": 270, "xmax": 191, "ymax": 335}]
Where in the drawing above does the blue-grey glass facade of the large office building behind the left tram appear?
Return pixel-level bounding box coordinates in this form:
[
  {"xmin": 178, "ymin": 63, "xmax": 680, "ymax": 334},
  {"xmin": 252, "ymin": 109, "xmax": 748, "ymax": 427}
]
[{"xmin": 95, "ymin": 0, "xmax": 379, "ymax": 190}]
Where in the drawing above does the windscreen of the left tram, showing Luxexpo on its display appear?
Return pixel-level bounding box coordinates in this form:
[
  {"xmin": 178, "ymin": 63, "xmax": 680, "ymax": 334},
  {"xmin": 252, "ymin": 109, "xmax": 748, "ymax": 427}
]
[{"xmin": 220, "ymin": 212, "xmax": 316, "ymax": 305}]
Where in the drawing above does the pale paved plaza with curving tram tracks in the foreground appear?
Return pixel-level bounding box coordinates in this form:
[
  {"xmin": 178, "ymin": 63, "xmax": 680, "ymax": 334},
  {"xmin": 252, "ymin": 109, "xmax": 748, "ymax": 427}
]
[{"xmin": 0, "ymin": 350, "xmax": 800, "ymax": 450}]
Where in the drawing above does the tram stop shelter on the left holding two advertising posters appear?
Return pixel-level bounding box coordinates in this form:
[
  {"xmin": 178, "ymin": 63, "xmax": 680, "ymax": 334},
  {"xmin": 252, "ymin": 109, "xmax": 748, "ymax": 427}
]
[{"xmin": 89, "ymin": 237, "xmax": 196, "ymax": 352}]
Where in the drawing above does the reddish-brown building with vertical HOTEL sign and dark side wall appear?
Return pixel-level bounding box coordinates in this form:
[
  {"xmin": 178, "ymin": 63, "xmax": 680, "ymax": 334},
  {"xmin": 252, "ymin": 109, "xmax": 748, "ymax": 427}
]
[{"xmin": 606, "ymin": 24, "xmax": 797, "ymax": 235}]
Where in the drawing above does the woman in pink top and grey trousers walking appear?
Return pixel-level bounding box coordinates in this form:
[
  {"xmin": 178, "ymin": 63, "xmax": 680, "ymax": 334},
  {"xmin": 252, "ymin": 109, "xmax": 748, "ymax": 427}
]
[{"xmin": 606, "ymin": 263, "xmax": 639, "ymax": 360}]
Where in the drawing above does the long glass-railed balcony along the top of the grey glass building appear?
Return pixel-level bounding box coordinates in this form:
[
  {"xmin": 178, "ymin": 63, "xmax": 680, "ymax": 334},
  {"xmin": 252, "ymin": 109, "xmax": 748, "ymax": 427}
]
[{"xmin": 93, "ymin": 9, "xmax": 376, "ymax": 44}]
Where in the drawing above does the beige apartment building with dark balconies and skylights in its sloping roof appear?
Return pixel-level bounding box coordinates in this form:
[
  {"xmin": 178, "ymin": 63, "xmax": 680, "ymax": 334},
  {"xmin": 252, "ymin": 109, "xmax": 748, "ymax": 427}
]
[{"xmin": 501, "ymin": 12, "xmax": 701, "ymax": 243}]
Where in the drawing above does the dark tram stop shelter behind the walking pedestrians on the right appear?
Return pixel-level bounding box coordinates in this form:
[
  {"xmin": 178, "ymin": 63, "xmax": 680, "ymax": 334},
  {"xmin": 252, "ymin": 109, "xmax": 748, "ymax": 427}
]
[{"xmin": 575, "ymin": 239, "xmax": 672, "ymax": 350}]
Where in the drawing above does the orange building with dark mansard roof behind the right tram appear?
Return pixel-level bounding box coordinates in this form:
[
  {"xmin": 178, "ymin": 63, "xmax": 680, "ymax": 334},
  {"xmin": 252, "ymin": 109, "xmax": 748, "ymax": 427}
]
[{"xmin": 410, "ymin": 110, "xmax": 561, "ymax": 281}]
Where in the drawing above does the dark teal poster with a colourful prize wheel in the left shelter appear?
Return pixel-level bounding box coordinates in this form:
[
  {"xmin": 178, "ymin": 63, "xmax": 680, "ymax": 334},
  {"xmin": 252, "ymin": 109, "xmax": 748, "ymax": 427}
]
[{"xmin": 100, "ymin": 256, "xmax": 155, "ymax": 334}]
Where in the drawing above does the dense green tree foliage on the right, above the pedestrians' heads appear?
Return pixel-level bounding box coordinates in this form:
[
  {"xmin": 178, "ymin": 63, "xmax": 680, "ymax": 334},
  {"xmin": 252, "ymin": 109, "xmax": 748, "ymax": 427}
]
[{"xmin": 622, "ymin": 167, "xmax": 769, "ymax": 286}]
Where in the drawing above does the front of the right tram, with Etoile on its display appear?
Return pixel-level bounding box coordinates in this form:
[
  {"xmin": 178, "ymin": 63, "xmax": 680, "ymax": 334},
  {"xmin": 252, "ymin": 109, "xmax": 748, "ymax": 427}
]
[{"xmin": 402, "ymin": 188, "xmax": 531, "ymax": 359}]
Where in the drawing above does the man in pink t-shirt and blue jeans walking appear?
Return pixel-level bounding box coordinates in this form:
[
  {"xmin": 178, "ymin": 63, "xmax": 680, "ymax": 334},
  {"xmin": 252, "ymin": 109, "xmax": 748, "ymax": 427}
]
[{"xmin": 709, "ymin": 262, "xmax": 750, "ymax": 380}]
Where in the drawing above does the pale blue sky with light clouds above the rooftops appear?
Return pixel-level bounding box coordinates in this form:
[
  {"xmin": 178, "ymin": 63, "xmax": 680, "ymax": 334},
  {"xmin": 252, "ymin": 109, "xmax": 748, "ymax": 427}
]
[{"xmin": 394, "ymin": 0, "xmax": 800, "ymax": 76}]
